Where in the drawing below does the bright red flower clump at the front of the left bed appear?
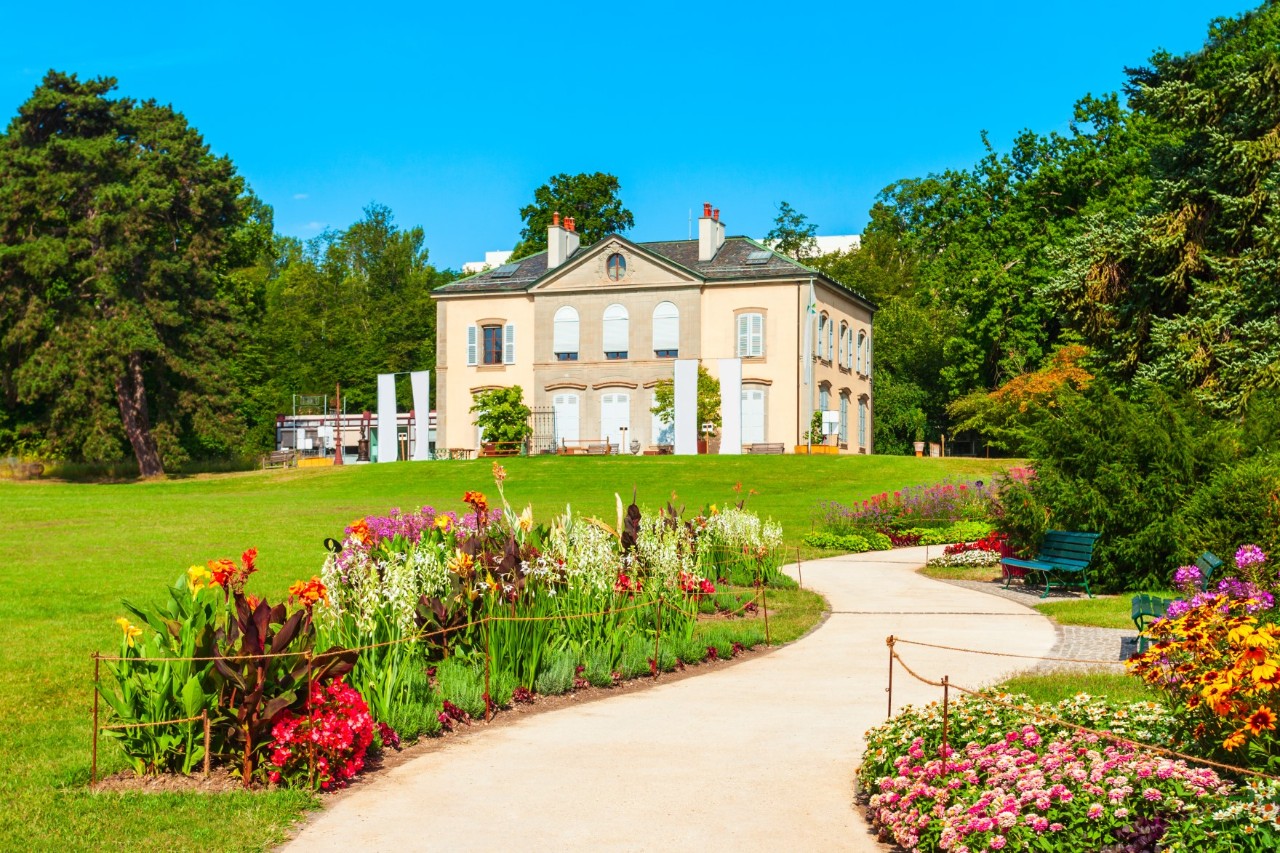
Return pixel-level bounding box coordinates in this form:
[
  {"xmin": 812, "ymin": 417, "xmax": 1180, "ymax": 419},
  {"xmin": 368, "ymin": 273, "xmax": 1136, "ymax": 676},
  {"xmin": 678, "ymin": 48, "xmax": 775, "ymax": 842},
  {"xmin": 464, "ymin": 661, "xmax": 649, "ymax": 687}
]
[{"xmin": 266, "ymin": 679, "xmax": 374, "ymax": 790}]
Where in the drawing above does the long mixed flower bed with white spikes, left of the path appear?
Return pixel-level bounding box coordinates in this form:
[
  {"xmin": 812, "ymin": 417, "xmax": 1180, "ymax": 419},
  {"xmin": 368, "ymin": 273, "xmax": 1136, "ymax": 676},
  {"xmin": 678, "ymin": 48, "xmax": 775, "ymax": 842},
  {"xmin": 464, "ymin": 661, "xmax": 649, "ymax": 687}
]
[{"xmin": 99, "ymin": 465, "xmax": 781, "ymax": 790}]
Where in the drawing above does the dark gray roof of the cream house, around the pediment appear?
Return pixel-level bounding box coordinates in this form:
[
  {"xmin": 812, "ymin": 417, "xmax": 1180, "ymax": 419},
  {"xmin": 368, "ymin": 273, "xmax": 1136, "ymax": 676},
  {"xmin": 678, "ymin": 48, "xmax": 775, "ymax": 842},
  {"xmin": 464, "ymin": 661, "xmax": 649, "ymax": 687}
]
[{"xmin": 434, "ymin": 237, "xmax": 874, "ymax": 307}]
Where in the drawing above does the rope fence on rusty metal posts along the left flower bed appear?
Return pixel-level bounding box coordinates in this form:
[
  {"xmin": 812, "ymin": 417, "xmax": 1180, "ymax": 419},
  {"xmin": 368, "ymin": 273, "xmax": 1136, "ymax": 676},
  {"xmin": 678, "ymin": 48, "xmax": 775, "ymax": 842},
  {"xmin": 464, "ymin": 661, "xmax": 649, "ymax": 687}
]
[{"xmin": 90, "ymin": 584, "xmax": 772, "ymax": 788}]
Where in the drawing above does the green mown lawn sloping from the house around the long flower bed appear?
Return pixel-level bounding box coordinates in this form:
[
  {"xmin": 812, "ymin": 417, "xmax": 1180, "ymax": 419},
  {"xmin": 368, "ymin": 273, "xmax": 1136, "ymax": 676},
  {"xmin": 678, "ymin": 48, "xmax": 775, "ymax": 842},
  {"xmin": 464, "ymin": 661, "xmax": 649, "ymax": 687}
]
[{"xmin": 0, "ymin": 456, "xmax": 998, "ymax": 849}]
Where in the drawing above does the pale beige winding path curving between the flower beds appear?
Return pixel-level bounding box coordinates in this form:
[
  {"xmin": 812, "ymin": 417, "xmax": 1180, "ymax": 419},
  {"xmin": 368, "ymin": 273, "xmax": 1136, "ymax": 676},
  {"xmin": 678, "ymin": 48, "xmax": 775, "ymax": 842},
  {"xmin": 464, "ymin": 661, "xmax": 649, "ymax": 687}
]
[{"xmin": 285, "ymin": 548, "xmax": 1055, "ymax": 853}]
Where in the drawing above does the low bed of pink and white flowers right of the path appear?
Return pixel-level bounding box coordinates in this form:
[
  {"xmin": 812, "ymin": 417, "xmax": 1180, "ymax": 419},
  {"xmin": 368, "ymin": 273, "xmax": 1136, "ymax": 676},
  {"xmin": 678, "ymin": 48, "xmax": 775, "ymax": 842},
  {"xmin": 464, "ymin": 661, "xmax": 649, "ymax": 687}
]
[{"xmin": 858, "ymin": 695, "xmax": 1280, "ymax": 853}]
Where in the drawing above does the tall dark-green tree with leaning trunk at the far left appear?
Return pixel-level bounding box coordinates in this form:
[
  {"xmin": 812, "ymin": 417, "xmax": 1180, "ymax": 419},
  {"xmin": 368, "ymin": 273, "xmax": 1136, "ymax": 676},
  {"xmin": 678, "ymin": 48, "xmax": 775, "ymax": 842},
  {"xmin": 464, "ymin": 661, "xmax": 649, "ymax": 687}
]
[{"xmin": 0, "ymin": 72, "xmax": 250, "ymax": 476}]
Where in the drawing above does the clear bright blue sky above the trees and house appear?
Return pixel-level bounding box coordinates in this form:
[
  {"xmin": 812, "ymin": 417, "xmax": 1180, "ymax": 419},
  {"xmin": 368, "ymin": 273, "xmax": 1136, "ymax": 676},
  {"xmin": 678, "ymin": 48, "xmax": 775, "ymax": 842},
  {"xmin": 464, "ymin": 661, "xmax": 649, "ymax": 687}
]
[{"xmin": 0, "ymin": 0, "xmax": 1257, "ymax": 266}]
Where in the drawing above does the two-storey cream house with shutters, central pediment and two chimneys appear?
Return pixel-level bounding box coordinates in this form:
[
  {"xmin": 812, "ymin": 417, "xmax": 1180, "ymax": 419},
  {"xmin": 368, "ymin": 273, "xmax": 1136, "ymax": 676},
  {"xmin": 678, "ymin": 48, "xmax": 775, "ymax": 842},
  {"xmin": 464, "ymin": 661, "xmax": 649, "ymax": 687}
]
[{"xmin": 434, "ymin": 205, "xmax": 876, "ymax": 453}]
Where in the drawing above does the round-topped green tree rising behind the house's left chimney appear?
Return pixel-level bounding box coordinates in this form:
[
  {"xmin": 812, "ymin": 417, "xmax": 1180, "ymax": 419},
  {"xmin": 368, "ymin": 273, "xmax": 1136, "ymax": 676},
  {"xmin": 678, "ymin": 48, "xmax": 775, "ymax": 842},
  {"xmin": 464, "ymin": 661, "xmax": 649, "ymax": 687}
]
[{"xmin": 511, "ymin": 172, "xmax": 635, "ymax": 259}]
